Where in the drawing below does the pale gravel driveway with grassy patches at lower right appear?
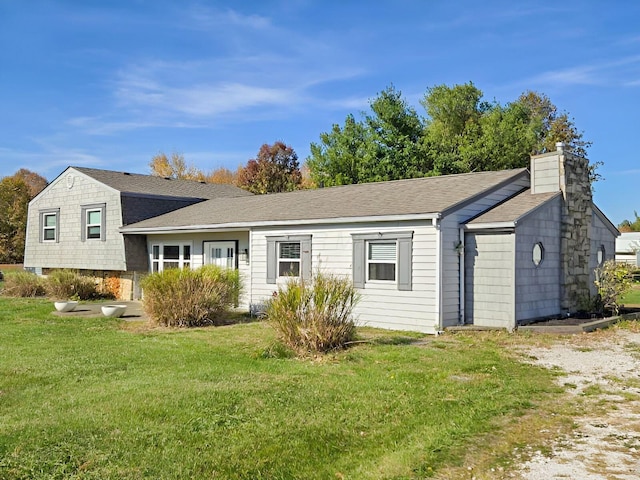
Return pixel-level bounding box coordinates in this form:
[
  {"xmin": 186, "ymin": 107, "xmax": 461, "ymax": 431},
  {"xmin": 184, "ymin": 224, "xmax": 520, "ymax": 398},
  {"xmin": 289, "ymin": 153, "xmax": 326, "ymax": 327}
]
[{"xmin": 517, "ymin": 329, "xmax": 640, "ymax": 480}]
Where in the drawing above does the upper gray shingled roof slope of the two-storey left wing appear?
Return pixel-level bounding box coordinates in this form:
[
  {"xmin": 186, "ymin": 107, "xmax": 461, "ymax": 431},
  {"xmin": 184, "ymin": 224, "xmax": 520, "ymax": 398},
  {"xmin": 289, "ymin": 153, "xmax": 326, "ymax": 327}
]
[{"xmin": 71, "ymin": 167, "xmax": 253, "ymax": 200}]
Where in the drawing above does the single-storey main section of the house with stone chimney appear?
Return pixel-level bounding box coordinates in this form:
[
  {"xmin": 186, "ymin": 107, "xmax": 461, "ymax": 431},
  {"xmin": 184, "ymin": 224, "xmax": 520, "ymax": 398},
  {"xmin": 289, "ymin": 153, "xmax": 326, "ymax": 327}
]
[{"xmin": 30, "ymin": 144, "xmax": 618, "ymax": 333}]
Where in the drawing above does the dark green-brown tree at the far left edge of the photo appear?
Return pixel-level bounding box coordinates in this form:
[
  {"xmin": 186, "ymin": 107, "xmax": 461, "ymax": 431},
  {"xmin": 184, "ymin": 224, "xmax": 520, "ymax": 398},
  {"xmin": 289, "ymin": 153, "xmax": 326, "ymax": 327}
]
[{"xmin": 0, "ymin": 176, "xmax": 32, "ymax": 263}]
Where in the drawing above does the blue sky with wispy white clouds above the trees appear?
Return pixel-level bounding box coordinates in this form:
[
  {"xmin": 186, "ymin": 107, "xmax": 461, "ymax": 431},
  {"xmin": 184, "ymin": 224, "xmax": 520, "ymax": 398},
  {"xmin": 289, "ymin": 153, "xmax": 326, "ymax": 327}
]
[{"xmin": 0, "ymin": 0, "xmax": 640, "ymax": 224}]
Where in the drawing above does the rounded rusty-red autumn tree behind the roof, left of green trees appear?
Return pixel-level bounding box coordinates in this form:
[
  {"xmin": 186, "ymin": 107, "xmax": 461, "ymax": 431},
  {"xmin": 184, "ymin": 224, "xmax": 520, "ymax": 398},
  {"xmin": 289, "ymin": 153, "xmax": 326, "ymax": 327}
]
[{"xmin": 237, "ymin": 141, "xmax": 302, "ymax": 194}]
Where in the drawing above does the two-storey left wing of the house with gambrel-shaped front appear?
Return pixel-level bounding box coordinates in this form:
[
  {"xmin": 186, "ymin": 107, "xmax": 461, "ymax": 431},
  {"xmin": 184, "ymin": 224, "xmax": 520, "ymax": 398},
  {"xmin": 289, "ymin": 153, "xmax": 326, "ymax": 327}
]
[{"xmin": 24, "ymin": 167, "xmax": 251, "ymax": 299}]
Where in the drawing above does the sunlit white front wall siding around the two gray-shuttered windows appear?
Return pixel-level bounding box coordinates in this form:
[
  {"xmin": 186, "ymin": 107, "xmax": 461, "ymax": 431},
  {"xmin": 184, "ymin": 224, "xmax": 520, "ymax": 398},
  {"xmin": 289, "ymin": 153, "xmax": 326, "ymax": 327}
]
[{"xmin": 251, "ymin": 221, "xmax": 438, "ymax": 333}]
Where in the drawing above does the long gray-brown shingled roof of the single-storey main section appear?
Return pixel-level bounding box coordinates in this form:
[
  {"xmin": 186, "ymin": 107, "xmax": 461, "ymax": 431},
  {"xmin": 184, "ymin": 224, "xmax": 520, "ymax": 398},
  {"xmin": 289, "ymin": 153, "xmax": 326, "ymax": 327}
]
[{"xmin": 123, "ymin": 168, "xmax": 527, "ymax": 231}]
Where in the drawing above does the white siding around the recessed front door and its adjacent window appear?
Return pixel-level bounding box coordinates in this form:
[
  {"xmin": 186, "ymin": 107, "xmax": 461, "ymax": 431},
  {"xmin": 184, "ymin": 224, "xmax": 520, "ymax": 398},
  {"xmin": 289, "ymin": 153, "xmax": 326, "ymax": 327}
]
[{"xmin": 147, "ymin": 231, "xmax": 251, "ymax": 309}]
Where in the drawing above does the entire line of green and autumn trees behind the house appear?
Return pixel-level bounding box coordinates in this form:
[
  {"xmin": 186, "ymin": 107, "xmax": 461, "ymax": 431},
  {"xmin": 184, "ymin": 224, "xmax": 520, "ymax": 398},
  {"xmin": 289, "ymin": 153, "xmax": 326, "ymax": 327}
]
[{"xmin": 0, "ymin": 82, "xmax": 628, "ymax": 263}]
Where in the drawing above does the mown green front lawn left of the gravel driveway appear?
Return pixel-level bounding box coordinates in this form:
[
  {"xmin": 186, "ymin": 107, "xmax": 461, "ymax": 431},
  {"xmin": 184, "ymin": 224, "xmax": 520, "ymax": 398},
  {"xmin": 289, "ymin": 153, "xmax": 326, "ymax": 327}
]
[{"xmin": 0, "ymin": 298, "xmax": 558, "ymax": 479}]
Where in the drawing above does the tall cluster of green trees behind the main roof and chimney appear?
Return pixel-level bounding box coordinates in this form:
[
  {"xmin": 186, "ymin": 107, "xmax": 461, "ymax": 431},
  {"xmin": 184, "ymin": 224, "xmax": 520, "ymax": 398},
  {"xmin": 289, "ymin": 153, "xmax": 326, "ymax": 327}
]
[{"xmin": 307, "ymin": 82, "xmax": 598, "ymax": 185}]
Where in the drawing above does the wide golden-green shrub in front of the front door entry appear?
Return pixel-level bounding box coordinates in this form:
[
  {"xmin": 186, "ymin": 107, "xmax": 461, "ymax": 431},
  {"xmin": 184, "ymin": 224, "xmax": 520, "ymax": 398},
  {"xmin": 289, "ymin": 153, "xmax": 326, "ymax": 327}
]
[{"xmin": 141, "ymin": 265, "xmax": 241, "ymax": 327}]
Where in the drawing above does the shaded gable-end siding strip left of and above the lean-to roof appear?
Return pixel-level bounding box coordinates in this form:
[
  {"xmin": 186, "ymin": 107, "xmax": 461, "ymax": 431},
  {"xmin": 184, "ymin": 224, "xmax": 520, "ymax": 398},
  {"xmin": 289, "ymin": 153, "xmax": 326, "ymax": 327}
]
[{"xmin": 440, "ymin": 177, "xmax": 529, "ymax": 327}]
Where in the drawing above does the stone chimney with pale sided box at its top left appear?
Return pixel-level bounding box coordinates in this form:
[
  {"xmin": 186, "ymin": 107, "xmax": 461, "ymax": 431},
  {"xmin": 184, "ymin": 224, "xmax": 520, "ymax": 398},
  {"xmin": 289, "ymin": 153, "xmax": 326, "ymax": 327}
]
[{"xmin": 531, "ymin": 142, "xmax": 592, "ymax": 312}]
